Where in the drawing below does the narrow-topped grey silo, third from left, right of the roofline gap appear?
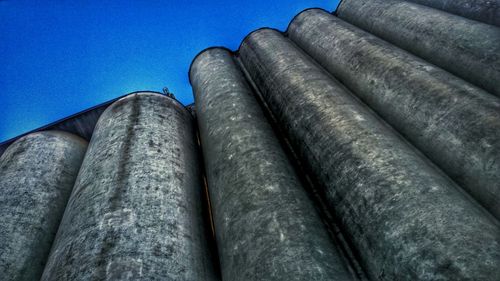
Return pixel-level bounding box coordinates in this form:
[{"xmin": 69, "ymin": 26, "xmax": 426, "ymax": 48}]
[{"xmin": 190, "ymin": 48, "xmax": 353, "ymax": 281}]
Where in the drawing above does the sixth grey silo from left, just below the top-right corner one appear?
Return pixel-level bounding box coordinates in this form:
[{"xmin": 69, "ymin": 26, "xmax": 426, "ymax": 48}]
[{"xmin": 337, "ymin": 0, "xmax": 500, "ymax": 96}]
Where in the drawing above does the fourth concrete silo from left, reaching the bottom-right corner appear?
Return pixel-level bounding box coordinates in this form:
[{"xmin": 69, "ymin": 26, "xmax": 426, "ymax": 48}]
[{"xmin": 239, "ymin": 29, "xmax": 500, "ymax": 281}]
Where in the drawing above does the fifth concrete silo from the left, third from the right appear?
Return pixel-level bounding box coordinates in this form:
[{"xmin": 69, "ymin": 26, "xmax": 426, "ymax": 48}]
[{"xmin": 288, "ymin": 9, "xmax": 500, "ymax": 221}]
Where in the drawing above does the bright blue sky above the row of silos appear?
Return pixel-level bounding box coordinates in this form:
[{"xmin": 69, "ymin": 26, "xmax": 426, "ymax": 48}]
[{"xmin": 0, "ymin": 0, "xmax": 339, "ymax": 142}]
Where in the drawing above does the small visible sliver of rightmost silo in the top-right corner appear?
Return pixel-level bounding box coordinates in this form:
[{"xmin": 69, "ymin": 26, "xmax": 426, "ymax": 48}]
[{"xmin": 408, "ymin": 0, "xmax": 500, "ymax": 26}]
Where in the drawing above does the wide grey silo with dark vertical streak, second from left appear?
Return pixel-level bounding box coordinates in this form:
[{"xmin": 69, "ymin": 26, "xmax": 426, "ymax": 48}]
[{"xmin": 42, "ymin": 93, "xmax": 216, "ymax": 280}]
